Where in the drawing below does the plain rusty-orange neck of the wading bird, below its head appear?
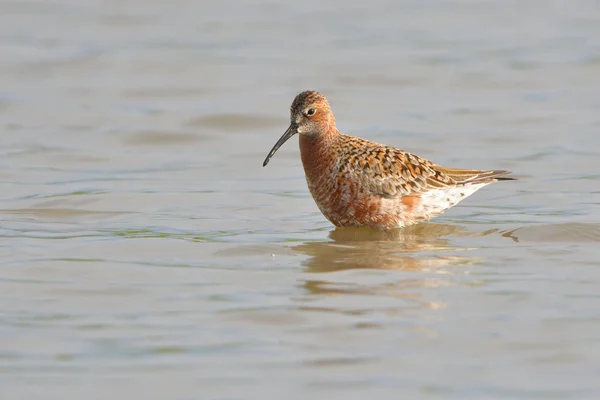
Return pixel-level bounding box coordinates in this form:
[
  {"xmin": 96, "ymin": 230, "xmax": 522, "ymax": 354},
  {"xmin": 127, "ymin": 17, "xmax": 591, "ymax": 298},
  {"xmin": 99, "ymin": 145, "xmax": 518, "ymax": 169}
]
[{"xmin": 299, "ymin": 127, "xmax": 340, "ymax": 179}]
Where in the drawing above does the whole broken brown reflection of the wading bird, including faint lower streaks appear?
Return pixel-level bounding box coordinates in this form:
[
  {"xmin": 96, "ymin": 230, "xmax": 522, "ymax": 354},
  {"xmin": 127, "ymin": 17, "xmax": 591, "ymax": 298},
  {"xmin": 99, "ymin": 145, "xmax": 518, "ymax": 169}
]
[{"xmin": 294, "ymin": 223, "xmax": 475, "ymax": 315}]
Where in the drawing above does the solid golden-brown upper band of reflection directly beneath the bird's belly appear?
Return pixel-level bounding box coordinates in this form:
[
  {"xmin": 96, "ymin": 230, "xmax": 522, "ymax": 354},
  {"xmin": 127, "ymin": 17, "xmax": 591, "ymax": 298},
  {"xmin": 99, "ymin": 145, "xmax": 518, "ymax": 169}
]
[{"xmin": 294, "ymin": 223, "xmax": 472, "ymax": 272}]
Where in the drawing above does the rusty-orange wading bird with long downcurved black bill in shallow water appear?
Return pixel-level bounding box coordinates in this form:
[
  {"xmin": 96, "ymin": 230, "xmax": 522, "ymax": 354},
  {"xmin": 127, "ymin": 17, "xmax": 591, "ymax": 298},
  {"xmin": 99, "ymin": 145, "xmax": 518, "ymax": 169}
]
[{"xmin": 263, "ymin": 90, "xmax": 514, "ymax": 230}]
